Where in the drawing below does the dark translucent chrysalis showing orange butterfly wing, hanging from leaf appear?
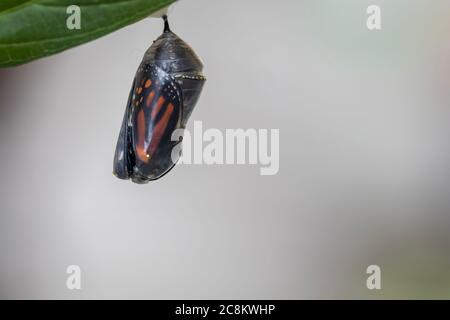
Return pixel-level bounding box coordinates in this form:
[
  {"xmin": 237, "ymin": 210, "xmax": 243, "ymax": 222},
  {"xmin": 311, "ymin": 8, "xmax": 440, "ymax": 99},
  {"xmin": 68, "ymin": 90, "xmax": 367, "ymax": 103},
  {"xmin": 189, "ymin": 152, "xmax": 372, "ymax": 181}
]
[{"xmin": 113, "ymin": 15, "xmax": 206, "ymax": 183}]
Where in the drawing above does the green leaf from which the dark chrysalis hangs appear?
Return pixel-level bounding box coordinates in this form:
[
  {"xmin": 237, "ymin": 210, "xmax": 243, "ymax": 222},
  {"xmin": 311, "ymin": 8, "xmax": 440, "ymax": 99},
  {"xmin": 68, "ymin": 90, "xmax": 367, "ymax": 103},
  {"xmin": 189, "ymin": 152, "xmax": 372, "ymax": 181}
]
[{"xmin": 0, "ymin": 0, "xmax": 175, "ymax": 67}]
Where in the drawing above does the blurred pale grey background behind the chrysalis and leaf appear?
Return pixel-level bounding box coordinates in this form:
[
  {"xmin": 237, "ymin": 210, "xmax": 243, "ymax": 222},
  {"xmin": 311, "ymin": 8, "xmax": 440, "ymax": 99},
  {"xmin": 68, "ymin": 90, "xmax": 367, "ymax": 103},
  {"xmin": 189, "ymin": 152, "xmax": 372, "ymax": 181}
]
[{"xmin": 0, "ymin": 0, "xmax": 450, "ymax": 299}]
